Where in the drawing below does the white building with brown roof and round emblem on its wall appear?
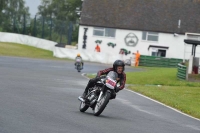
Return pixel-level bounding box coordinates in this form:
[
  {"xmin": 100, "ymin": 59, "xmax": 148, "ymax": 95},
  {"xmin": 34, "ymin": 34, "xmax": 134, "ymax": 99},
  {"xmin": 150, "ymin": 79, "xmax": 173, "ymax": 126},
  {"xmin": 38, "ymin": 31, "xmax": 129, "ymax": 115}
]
[{"xmin": 78, "ymin": 0, "xmax": 200, "ymax": 59}]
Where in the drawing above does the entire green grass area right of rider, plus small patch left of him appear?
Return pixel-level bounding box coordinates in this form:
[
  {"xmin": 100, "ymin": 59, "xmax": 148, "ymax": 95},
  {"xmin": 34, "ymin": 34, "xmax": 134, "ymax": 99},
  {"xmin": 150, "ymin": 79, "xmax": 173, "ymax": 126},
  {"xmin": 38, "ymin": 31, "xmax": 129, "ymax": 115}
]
[{"xmin": 87, "ymin": 67, "xmax": 200, "ymax": 119}]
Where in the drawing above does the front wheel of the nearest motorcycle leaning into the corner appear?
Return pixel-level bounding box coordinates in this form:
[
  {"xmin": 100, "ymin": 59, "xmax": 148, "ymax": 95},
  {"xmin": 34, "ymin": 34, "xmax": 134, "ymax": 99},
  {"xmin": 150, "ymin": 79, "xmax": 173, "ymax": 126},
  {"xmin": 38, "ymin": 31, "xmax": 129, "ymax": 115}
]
[{"xmin": 93, "ymin": 91, "xmax": 111, "ymax": 116}]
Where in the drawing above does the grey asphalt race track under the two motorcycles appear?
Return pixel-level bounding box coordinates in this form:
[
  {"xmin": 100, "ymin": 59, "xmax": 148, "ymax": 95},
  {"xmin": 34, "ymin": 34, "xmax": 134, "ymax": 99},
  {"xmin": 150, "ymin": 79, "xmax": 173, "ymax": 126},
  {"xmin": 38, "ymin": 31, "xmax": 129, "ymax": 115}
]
[{"xmin": 0, "ymin": 57, "xmax": 200, "ymax": 133}]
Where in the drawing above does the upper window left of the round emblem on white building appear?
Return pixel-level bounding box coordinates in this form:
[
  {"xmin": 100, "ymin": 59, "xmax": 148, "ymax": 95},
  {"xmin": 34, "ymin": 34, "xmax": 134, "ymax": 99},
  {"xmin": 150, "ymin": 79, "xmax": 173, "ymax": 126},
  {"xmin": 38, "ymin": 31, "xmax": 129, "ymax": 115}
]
[{"xmin": 93, "ymin": 27, "xmax": 116, "ymax": 37}]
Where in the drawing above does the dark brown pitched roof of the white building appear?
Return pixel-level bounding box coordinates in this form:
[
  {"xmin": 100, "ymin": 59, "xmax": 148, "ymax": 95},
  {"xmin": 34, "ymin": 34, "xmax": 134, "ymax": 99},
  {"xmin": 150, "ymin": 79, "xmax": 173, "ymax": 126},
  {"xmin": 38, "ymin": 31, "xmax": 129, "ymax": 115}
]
[{"xmin": 80, "ymin": 0, "xmax": 200, "ymax": 34}]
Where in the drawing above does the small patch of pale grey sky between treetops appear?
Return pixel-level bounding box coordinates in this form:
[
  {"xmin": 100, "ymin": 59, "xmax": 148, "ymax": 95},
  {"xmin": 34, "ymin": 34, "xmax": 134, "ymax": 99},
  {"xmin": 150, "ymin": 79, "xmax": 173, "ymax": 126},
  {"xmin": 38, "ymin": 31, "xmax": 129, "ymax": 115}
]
[{"xmin": 25, "ymin": 0, "xmax": 41, "ymax": 16}]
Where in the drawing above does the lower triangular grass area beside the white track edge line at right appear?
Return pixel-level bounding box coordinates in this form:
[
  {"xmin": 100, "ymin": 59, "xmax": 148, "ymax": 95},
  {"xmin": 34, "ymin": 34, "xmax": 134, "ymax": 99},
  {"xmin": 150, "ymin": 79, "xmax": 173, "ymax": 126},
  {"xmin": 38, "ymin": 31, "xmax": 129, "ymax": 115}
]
[{"xmin": 129, "ymin": 86, "xmax": 200, "ymax": 119}]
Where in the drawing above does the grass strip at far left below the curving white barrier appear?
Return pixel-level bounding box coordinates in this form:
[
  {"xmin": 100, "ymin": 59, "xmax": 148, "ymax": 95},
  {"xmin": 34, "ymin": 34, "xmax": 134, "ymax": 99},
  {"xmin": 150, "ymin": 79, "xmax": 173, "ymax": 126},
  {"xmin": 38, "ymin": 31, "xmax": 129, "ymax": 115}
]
[{"xmin": 0, "ymin": 42, "xmax": 69, "ymax": 60}]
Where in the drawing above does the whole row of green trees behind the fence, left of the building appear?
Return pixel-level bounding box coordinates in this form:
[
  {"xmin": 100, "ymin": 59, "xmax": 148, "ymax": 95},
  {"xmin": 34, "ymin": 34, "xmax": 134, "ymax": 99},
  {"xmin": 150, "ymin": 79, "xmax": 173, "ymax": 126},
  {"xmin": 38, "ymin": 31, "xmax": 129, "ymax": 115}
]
[{"xmin": 0, "ymin": 0, "xmax": 82, "ymax": 42}]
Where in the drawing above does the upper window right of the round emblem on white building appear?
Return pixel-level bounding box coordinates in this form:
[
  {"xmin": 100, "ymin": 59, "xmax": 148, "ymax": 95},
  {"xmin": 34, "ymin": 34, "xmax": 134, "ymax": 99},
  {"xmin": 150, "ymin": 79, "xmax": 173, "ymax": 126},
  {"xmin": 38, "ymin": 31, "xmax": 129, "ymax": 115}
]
[{"xmin": 142, "ymin": 31, "xmax": 158, "ymax": 42}]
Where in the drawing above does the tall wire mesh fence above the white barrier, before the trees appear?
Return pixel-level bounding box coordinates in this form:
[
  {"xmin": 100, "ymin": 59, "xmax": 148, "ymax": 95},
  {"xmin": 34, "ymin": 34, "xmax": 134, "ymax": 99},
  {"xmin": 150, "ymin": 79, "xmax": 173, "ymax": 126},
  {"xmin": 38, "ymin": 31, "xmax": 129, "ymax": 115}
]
[{"xmin": 0, "ymin": 15, "xmax": 78, "ymax": 45}]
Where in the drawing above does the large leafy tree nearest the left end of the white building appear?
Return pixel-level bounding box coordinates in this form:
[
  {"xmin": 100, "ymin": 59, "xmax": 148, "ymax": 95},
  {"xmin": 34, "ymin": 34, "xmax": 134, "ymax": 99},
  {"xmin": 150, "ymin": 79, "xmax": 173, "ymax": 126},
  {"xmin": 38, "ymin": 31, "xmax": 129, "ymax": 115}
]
[{"xmin": 38, "ymin": 0, "xmax": 82, "ymax": 42}]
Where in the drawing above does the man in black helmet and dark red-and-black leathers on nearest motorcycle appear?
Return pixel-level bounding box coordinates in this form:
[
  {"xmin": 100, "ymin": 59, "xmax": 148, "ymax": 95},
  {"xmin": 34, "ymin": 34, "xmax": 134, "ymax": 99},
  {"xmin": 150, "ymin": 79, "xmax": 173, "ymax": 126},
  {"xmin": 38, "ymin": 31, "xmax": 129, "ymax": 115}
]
[{"xmin": 82, "ymin": 60, "xmax": 126, "ymax": 99}]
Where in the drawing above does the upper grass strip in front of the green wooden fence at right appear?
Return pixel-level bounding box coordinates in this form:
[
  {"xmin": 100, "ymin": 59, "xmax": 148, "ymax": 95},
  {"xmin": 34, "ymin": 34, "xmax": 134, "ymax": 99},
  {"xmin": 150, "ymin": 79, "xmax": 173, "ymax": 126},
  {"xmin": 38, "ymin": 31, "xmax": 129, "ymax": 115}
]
[{"xmin": 126, "ymin": 67, "xmax": 200, "ymax": 87}]
